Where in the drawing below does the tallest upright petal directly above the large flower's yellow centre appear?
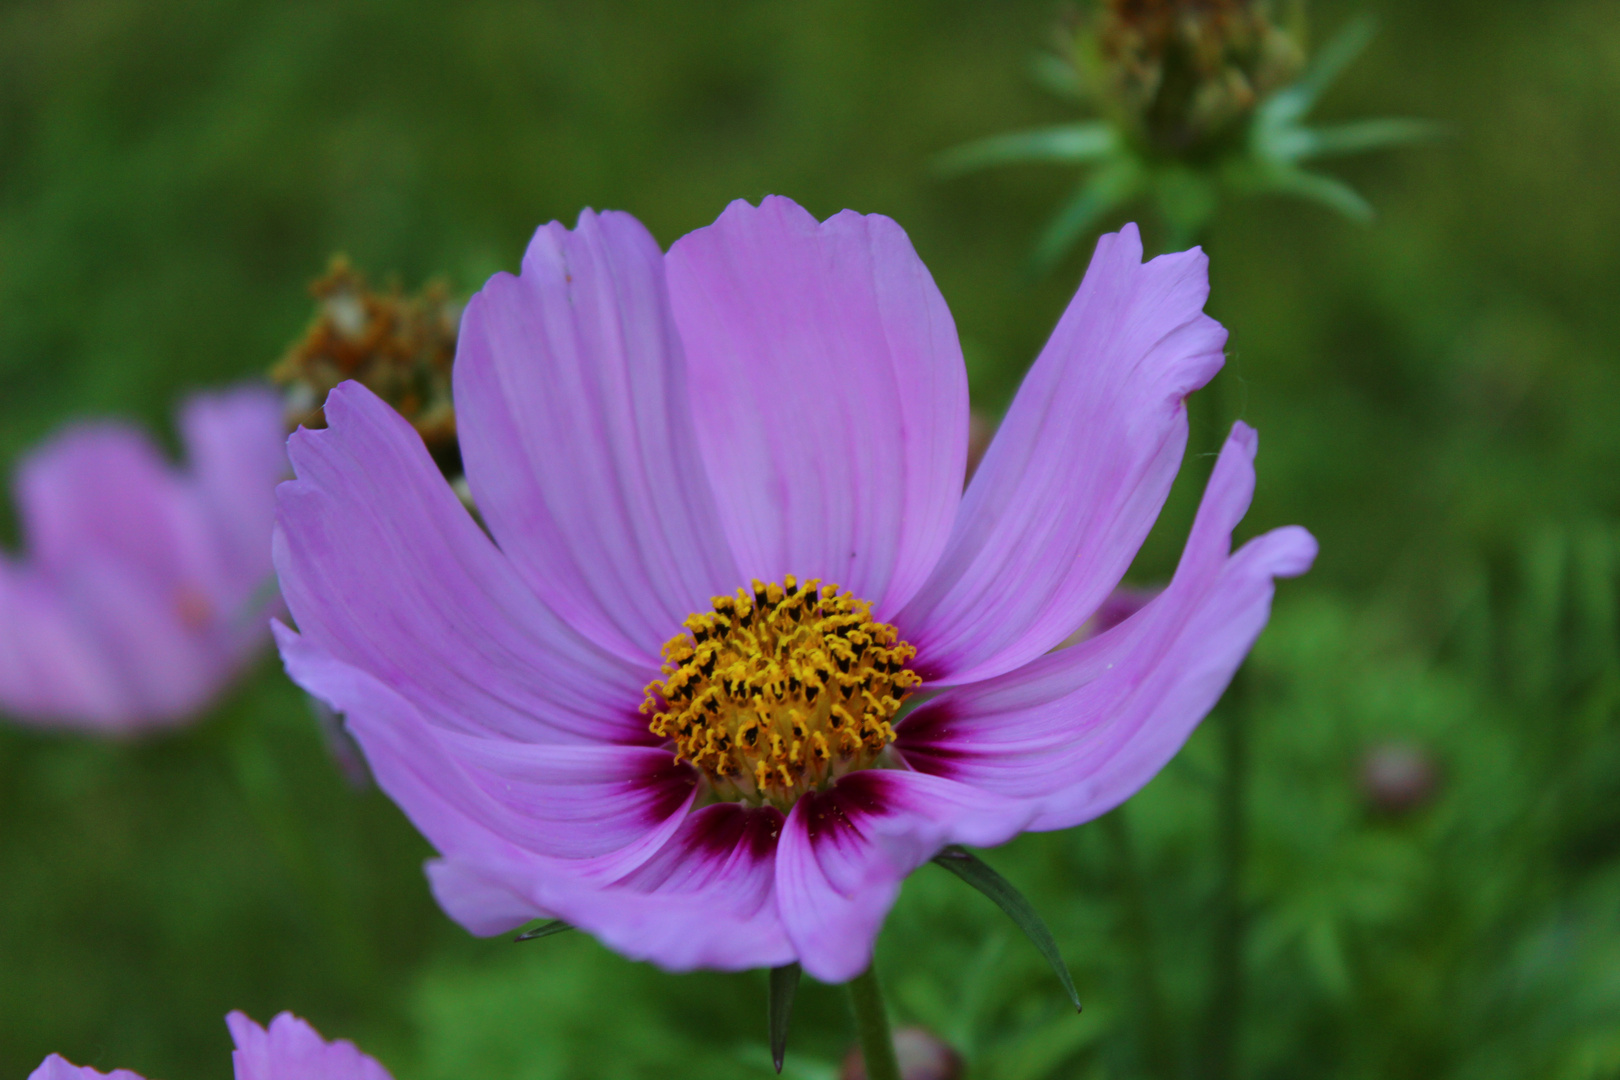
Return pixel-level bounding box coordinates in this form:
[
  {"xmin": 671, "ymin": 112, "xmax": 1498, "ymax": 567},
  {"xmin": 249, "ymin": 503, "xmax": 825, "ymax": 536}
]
[{"xmin": 669, "ymin": 196, "xmax": 967, "ymax": 619}]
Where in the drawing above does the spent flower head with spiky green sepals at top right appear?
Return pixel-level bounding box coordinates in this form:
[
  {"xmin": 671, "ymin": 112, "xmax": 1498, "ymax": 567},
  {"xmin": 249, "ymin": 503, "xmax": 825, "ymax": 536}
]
[{"xmin": 936, "ymin": 0, "xmax": 1435, "ymax": 270}]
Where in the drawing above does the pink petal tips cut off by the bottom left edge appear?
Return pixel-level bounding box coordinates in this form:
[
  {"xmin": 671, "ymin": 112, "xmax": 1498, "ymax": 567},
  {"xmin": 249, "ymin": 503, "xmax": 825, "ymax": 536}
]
[{"xmin": 28, "ymin": 1012, "xmax": 392, "ymax": 1080}]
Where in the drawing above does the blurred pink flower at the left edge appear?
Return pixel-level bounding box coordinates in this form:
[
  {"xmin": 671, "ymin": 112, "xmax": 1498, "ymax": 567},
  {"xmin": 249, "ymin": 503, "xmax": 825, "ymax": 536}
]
[{"xmin": 0, "ymin": 389, "xmax": 287, "ymax": 735}]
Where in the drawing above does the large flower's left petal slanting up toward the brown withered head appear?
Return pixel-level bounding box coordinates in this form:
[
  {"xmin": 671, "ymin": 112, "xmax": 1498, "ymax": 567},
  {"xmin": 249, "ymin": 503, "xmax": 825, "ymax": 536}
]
[{"xmin": 275, "ymin": 382, "xmax": 656, "ymax": 743}]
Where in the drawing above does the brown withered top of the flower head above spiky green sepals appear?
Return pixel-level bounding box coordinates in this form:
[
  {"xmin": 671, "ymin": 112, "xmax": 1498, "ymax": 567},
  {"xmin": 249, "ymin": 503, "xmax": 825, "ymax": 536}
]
[{"xmin": 1076, "ymin": 0, "xmax": 1304, "ymax": 157}]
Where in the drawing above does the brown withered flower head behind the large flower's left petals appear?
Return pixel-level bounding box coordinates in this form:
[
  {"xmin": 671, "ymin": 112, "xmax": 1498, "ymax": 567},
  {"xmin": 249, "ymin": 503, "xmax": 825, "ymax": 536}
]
[{"xmin": 271, "ymin": 256, "xmax": 462, "ymax": 471}]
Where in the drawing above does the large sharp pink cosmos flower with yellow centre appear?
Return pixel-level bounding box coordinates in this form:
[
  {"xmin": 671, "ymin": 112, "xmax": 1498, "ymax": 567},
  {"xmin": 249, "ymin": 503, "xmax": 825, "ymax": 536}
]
[{"xmin": 275, "ymin": 198, "xmax": 1315, "ymax": 981}]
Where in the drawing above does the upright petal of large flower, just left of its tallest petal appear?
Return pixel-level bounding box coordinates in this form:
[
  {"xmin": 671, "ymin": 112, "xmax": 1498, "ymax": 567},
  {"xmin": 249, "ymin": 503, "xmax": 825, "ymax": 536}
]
[{"xmin": 454, "ymin": 210, "xmax": 739, "ymax": 665}]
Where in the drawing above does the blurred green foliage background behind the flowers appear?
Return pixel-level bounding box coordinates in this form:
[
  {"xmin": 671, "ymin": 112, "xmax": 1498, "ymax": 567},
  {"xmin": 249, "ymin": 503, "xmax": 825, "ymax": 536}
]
[{"xmin": 0, "ymin": 0, "xmax": 1620, "ymax": 1080}]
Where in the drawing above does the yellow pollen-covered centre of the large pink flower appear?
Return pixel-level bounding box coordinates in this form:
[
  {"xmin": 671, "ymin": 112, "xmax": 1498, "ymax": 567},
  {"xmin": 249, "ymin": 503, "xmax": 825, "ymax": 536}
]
[{"xmin": 642, "ymin": 575, "xmax": 922, "ymax": 810}]
